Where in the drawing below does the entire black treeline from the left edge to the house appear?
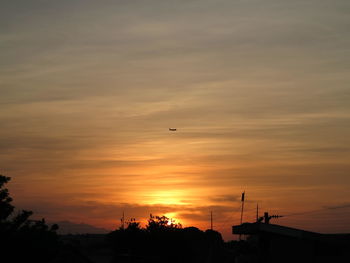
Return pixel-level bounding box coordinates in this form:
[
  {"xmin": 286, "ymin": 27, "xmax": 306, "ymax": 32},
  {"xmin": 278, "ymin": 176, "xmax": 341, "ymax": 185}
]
[{"xmin": 0, "ymin": 175, "xmax": 244, "ymax": 263}]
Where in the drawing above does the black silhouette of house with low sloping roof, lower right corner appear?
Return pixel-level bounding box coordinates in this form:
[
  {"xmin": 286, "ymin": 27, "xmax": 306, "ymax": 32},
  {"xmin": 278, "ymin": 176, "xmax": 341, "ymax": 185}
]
[{"xmin": 232, "ymin": 221, "xmax": 350, "ymax": 263}]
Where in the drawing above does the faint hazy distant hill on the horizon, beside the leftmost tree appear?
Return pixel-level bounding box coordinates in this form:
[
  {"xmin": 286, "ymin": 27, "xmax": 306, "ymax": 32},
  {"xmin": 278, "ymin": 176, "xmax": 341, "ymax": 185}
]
[{"xmin": 55, "ymin": 221, "xmax": 110, "ymax": 235}]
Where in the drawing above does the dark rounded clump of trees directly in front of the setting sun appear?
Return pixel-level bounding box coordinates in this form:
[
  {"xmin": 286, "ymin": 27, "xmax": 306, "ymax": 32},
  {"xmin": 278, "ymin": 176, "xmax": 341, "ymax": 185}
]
[{"xmin": 108, "ymin": 215, "xmax": 231, "ymax": 262}]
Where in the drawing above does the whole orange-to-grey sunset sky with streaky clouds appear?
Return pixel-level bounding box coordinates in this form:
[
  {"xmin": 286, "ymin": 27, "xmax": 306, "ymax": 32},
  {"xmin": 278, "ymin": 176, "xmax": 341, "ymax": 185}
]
[{"xmin": 0, "ymin": 0, "xmax": 350, "ymax": 239}]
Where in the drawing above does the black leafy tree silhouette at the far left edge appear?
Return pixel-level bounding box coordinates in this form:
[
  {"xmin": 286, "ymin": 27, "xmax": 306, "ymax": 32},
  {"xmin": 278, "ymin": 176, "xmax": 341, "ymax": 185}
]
[{"xmin": 0, "ymin": 175, "xmax": 58, "ymax": 263}]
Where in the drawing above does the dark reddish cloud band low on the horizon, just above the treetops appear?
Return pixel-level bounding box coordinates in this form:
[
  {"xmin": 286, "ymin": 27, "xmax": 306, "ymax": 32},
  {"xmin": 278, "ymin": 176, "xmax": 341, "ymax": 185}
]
[{"xmin": 21, "ymin": 200, "xmax": 236, "ymax": 227}]
